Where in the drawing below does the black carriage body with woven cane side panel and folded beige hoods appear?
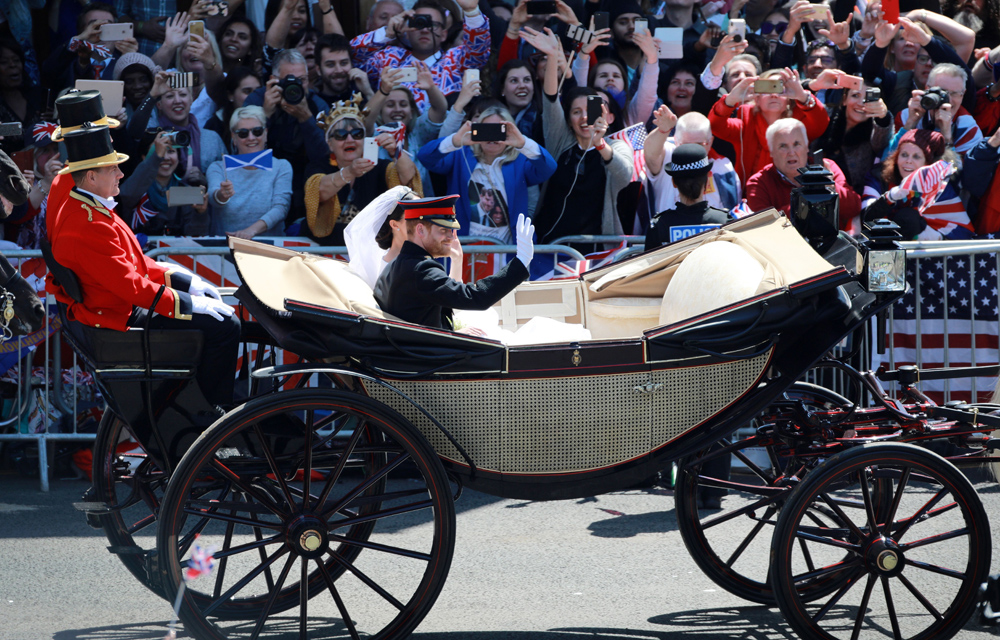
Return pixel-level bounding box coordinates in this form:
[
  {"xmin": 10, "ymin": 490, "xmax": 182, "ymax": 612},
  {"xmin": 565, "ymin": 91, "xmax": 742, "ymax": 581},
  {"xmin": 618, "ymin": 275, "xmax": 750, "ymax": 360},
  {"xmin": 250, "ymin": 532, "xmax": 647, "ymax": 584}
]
[{"xmin": 234, "ymin": 212, "xmax": 900, "ymax": 500}]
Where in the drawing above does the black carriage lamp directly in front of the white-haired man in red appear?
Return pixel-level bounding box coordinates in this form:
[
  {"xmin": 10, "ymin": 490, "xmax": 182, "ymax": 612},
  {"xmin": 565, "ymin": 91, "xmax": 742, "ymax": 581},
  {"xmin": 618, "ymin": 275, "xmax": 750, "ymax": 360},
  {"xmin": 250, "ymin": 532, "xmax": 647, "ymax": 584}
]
[{"xmin": 789, "ymin": 164, "xmax": 840, "ymax": 254}]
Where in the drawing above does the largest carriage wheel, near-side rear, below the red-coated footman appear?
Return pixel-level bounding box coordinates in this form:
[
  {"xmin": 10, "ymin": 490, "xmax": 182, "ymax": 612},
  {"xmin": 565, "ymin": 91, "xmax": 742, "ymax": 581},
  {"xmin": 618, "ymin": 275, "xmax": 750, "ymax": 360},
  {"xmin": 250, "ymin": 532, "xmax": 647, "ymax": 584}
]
[{"xmin": 157, "ymin": 390, "xmax": 455, "ymax": 639}]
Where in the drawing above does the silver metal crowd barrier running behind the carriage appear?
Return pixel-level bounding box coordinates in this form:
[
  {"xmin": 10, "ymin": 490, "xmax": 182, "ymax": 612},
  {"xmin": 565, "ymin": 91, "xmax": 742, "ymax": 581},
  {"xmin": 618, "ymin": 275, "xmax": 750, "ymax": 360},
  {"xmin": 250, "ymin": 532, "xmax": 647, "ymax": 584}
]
[{"xmin": 0, "ymin": 235, "xmax": 1000, "ymax": 491}]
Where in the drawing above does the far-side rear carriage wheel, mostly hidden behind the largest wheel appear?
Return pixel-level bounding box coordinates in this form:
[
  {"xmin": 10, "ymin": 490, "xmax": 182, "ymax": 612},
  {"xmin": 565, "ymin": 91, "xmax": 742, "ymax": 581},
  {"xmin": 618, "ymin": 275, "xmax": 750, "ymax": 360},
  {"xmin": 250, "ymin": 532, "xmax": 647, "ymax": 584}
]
[{"xmin": 88, "ymin": 409, "xmax": 167, "ymax": 594}]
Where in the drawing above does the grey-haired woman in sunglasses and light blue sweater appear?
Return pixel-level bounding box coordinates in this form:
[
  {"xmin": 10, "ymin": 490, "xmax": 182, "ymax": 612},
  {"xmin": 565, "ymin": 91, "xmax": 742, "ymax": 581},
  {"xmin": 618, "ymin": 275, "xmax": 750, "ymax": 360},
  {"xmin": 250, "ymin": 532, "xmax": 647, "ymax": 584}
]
[{"xmin": 208, "ymin": 107, "xmax": 292, "ymax": 239}]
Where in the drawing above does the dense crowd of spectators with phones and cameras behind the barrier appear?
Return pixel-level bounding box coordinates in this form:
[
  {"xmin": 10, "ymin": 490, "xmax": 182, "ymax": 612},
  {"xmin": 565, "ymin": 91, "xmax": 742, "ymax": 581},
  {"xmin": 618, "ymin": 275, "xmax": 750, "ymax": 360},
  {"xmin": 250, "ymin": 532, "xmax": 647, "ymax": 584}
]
[{"xmin": 0, "ymin": 0, "xmax": 1000, "ymax": 268}]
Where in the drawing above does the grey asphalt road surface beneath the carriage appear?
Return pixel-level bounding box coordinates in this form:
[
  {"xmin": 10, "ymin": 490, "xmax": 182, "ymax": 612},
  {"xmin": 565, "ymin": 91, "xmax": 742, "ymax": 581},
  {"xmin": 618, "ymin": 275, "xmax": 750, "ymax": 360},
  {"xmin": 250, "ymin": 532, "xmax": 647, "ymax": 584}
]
[{"xmin": 0, "ymin": 475, "xmax": 1000, "ymax": 640}]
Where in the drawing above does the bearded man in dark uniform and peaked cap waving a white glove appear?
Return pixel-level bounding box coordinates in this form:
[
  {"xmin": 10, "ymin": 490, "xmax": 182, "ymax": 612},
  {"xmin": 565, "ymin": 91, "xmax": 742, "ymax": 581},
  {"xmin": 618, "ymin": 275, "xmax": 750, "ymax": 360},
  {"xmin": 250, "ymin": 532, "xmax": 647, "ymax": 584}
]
[{"xmin": 375, "ymin": 196, "xmax": 535, "ymax": 330}]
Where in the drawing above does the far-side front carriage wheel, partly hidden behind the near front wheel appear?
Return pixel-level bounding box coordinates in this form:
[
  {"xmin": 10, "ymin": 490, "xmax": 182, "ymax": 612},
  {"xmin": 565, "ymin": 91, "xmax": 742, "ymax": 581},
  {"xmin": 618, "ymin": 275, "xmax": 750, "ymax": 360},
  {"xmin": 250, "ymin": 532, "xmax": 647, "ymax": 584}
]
[{"xmin": 674, "ymin": 382, "xmax": 851, "ymax": 605}]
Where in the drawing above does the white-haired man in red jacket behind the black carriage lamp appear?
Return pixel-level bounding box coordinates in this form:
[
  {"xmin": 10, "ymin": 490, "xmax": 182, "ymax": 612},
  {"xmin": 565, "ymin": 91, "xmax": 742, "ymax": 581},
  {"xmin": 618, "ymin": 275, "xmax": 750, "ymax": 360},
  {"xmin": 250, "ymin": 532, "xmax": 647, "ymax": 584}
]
[{"xmin": 746, "ymin": 118, "xmax": 861, "ymax": 233}]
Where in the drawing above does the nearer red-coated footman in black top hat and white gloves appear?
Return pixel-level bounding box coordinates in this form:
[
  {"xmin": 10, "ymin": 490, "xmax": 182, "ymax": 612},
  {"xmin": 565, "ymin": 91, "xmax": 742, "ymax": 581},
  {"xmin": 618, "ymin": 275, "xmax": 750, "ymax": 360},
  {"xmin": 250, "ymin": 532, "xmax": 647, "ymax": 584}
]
[{"xmin": 42, "ymin": 124, "xmax": 240, "ymax": 405}]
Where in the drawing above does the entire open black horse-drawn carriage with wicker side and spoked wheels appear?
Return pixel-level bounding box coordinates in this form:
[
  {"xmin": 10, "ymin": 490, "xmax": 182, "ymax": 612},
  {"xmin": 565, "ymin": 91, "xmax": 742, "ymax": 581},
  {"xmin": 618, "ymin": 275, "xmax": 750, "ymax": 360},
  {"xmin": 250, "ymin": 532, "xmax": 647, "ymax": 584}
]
[{"xmin": 58, "ymin": 211, "xmax": 1000, "ymax": 639}]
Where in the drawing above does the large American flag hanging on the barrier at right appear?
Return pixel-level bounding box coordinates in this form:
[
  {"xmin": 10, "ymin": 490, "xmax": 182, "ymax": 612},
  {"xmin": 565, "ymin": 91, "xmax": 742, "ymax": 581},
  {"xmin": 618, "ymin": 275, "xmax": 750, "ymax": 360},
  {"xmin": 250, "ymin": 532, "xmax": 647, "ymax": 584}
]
[{"xmin": 888, "ymin": 242, "xmax": 1000, "ymax": 402}]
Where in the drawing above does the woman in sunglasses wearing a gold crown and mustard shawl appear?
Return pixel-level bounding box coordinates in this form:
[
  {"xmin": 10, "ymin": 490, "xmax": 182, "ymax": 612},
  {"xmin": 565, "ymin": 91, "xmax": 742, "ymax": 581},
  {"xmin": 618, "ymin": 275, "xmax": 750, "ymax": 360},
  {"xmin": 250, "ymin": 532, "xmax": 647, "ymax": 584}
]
[{"xmin": 305, "ymin": 100, "xmax": 423, "ymax": 246}]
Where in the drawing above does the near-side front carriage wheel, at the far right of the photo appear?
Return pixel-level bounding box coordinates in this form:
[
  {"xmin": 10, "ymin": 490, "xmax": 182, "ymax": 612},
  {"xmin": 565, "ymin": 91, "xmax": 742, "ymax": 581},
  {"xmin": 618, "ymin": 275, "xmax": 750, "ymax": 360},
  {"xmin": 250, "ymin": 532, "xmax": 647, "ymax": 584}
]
[{"xmin": 772, "ymin": 443, "xmax": 991, "ymax": 640}]
